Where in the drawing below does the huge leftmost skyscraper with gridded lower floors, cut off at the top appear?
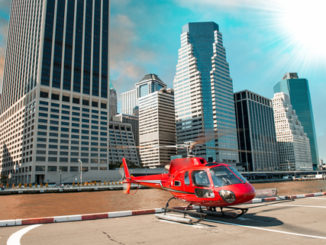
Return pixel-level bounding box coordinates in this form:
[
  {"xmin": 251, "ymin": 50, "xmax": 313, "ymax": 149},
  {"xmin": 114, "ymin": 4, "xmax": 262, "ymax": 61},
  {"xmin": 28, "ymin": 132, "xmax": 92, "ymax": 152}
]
[{"xmin": 0, "ymin": 0, "xmax": 109, "ymax": 183}]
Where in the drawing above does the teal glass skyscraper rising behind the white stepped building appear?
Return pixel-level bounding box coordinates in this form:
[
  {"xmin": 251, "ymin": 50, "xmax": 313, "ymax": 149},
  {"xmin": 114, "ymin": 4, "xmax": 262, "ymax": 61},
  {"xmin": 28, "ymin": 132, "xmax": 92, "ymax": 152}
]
[{"xmin": 274, "ymin": 73, "xmax": 319, "ymax": 169}]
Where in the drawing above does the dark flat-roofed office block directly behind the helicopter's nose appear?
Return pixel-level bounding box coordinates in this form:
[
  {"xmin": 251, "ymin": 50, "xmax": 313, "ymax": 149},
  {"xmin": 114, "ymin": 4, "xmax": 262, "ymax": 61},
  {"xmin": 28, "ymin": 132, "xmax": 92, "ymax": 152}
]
[{"xmin": 234, "ymin": 90, "xmax": 280, "ymax": 171}]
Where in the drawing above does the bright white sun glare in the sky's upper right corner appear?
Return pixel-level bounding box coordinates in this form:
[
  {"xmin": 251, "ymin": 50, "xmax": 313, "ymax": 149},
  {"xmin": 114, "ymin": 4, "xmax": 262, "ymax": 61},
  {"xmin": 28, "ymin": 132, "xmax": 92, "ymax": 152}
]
[{"xmin": 278, "ymin": 0, "xmax": 326, "ymax": 62}]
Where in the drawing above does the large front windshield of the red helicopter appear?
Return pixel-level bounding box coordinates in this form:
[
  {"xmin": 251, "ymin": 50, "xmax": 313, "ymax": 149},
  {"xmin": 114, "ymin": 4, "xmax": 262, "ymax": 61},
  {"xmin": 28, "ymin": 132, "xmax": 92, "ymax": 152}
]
[{"xmin": 210, "ymin": 166, "xmax": 242, "ymax": 187}]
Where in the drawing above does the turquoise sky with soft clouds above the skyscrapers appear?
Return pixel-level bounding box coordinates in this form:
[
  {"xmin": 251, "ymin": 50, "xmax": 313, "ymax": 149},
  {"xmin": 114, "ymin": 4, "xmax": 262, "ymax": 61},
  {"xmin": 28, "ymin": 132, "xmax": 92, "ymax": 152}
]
[{"xmin": 0, "ymin": 0, "xmax": 326, "ymax": 160}]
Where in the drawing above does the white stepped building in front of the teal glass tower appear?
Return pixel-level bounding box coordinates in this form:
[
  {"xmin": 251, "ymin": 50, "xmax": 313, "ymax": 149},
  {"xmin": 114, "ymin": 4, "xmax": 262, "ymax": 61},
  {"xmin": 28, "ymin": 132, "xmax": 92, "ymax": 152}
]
[{"xmin": 273, "ymin": 92, "xmax": 312, "ymax": 171}]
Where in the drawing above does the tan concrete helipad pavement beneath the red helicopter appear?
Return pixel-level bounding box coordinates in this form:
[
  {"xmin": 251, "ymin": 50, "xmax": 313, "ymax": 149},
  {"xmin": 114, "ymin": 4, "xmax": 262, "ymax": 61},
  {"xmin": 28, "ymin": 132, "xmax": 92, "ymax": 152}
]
[{"xmin": 0, "ymin": 196, "xmax": 326, "ymax": 245}]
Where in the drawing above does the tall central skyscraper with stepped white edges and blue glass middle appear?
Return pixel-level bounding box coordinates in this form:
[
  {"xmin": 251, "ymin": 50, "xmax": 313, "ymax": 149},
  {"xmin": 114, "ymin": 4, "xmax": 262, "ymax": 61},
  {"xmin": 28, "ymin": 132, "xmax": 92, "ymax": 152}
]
[{"xmin": 174, "ymin": 22, "xmax": 238, "ymax": 163}]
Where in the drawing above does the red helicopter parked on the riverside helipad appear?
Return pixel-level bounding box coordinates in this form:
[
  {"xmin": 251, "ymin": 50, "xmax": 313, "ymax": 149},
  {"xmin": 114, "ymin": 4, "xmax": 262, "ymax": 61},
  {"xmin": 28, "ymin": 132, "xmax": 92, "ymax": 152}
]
[{"xmin": 123, "ymin": 143, "xmax": 255, "ymax": 217}]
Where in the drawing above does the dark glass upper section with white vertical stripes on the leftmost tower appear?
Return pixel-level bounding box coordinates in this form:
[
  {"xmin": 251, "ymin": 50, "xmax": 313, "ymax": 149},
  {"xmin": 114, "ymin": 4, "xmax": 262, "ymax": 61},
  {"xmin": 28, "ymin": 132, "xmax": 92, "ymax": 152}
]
[{"xmin": 41, "ymin": 0, "xmax": 109, "ymax": 98}]
